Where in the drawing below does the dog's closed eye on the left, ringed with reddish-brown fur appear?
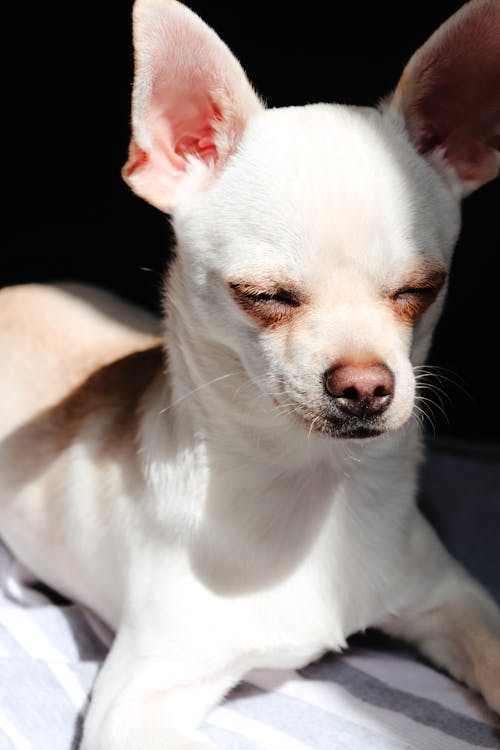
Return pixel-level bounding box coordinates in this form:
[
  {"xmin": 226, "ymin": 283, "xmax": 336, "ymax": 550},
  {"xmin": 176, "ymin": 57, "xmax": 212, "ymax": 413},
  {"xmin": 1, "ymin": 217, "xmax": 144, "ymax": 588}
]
[{"xmin": 228, "ymin": 281, "xmax": 304, "ymax": 328}]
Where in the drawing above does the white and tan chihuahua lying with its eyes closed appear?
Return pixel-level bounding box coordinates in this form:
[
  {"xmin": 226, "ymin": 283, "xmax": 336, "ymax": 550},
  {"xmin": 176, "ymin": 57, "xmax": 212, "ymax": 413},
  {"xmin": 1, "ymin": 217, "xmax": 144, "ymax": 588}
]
[{"xmin": 0, "ymin": 0, "xmax": 500, "ymax": 750}]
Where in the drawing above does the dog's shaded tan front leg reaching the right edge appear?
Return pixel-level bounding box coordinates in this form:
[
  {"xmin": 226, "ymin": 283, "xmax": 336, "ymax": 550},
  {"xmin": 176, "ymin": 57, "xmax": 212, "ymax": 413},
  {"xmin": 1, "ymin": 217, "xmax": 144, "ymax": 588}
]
[{"xmin": 380, "ymin": 514, "xmax": 500, "ymax": 713}]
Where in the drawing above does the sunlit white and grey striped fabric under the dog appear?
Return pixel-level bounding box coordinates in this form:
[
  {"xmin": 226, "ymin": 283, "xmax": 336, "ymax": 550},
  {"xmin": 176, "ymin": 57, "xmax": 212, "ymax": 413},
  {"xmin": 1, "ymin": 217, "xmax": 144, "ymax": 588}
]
[{"xmin": 0, "ymin": 546, "xmax": 500, "ymax": 750}]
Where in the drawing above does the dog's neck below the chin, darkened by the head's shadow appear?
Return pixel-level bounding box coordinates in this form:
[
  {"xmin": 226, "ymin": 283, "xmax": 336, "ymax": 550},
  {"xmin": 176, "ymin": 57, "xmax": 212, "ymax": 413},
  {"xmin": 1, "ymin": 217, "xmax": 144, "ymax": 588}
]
[{"xmin": 138, "ymin": 320, "xmax": 418, "ymax": 596}]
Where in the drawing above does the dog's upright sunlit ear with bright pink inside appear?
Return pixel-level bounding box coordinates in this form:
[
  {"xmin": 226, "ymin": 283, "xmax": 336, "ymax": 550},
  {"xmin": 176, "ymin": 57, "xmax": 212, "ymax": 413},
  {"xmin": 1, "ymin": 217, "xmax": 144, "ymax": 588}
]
[{"xmin": 122, "ymin": 0, "xmax": 262, "ymax": 212}]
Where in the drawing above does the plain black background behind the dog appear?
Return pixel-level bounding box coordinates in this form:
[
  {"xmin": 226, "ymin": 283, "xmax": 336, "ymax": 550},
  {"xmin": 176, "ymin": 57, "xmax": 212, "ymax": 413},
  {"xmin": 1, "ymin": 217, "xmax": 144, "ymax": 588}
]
[{"xmin": 4, "ymin": 0, "xmax": 500, "ymax": 441}]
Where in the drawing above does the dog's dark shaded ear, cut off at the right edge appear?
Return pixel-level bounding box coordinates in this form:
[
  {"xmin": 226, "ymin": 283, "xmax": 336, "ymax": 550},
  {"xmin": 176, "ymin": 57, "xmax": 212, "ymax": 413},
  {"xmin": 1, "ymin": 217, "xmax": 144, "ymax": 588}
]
[{"xmin": 389, "ymin": 0, "xmax": 500, "ymax": 196}]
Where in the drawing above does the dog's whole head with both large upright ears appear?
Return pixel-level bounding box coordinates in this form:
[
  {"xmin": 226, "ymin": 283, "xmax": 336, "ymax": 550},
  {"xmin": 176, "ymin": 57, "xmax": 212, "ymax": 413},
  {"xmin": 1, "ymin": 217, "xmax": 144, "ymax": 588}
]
[{"xmin": 124, "ymin": 0, "xmax": 500, "ymax": 438}]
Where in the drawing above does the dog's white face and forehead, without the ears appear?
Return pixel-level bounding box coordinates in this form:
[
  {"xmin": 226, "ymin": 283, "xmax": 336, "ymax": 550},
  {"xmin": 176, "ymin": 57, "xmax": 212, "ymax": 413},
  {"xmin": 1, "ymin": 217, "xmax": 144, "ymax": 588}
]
[{"xmin": 175, "ymin": 105, "xmax": 458, "ymax": 438}]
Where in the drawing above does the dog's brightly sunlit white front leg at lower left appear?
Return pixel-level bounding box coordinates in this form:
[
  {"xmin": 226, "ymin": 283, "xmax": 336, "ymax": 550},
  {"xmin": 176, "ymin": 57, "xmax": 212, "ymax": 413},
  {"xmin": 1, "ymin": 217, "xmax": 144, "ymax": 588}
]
[{"xmin": 81, "ymin": 632, "xmax": 239, "ymax": 750}]
